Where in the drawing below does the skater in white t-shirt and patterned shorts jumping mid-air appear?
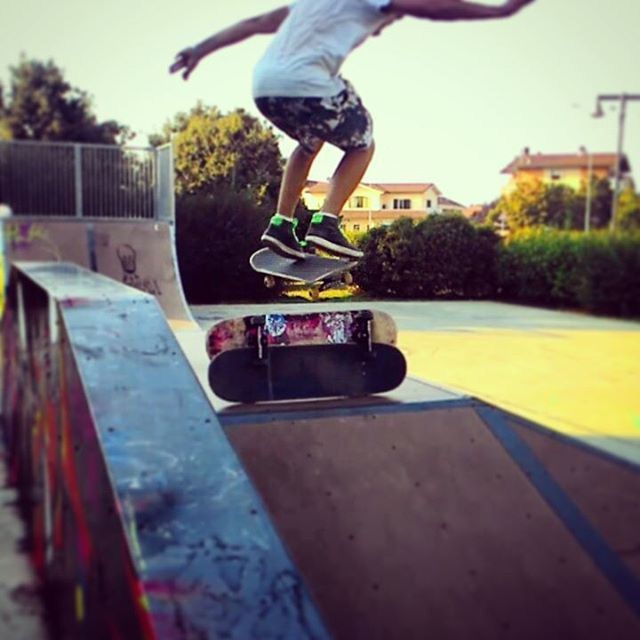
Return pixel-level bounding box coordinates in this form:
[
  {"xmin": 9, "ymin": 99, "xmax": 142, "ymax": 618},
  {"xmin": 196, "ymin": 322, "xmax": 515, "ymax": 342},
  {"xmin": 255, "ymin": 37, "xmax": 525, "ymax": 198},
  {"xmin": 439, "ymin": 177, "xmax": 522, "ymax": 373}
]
[{"xmin": 171, "ymin": 0, "xmax": 534, "ymax": 258}]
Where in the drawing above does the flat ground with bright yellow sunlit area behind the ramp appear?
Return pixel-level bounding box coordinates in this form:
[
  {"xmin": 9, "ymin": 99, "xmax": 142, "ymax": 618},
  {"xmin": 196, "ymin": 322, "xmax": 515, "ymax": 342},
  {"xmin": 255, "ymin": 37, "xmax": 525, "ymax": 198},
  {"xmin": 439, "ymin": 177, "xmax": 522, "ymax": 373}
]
[{"xmin": 192, "ymin": 301, "xmax": 640, "ymax": 464}]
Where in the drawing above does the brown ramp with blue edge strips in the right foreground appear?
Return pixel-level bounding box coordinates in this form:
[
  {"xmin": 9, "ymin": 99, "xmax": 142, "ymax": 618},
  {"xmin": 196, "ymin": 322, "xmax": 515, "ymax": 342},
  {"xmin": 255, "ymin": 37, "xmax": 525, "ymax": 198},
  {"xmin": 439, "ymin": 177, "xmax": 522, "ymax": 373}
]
[{"xmin": 222, "ymin": 399, "xmax": 640, "ymax": 640}]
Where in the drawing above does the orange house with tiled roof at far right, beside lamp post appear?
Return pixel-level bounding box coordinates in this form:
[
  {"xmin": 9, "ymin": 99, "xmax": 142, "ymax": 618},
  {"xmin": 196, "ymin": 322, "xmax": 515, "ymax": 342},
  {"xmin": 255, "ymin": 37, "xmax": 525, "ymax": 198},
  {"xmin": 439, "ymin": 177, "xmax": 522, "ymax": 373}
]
[{"xmin": 501, "ymin": 147, "xmax": 631, "ymax": 193}]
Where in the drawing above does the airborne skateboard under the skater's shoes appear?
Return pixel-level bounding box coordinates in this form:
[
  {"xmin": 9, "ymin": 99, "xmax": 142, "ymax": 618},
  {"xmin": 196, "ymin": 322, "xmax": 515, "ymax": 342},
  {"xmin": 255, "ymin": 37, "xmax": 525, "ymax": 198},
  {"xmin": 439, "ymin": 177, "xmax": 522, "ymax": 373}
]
[{"xmin": 249, "ymin": 249, "xmax": 357, "ymax": 300}]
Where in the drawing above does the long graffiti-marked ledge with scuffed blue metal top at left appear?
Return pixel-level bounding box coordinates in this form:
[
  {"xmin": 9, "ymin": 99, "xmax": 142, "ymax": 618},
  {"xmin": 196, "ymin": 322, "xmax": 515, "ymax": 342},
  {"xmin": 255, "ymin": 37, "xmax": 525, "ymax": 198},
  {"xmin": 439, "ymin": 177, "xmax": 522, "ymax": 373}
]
[{"xmin": 3, "ymin": 263, "xmax": 327, "ymax": 640}]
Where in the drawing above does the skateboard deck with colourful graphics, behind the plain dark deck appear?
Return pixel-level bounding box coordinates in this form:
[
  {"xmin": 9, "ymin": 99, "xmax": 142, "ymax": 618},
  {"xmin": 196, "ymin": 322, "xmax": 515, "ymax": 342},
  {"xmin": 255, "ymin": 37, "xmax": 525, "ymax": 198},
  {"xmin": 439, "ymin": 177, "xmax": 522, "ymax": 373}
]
[{"xmin": 205, "ymin": 310, "xmax": 398, "ymax": 359}]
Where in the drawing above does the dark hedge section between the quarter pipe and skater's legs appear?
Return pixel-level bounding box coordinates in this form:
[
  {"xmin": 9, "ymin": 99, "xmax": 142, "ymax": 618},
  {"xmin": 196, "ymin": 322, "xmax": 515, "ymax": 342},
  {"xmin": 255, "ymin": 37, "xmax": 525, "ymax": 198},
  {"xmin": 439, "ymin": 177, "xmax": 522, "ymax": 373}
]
[{"xmin": 176, "ymin": 190, "xmax": 277, "ymax": 304}]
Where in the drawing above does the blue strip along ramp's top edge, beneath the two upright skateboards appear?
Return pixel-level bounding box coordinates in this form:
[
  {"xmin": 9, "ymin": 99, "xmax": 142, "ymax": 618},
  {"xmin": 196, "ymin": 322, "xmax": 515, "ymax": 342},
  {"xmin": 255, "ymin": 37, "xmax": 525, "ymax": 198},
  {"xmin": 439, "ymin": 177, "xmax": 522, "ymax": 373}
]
[{"xmin": 217, "ymin": 398, "xmax": 476, "ymax": 428}]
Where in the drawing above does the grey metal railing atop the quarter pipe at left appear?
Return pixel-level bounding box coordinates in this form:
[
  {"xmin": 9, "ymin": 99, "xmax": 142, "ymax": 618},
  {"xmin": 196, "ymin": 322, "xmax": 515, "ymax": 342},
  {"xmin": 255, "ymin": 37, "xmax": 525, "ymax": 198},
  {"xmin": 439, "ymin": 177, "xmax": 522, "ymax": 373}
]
[{"xmin": 0, "ymin": 140, "xmax": 175, "ymax": 220}]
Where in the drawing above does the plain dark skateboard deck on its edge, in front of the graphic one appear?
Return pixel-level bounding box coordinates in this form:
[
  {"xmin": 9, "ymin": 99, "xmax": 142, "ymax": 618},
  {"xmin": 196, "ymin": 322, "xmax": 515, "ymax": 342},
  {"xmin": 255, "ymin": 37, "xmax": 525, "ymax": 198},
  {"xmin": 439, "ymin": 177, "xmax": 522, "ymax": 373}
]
[{"xmin": 209, "ymin": 343, "xmax": 407, "ymax": 403}]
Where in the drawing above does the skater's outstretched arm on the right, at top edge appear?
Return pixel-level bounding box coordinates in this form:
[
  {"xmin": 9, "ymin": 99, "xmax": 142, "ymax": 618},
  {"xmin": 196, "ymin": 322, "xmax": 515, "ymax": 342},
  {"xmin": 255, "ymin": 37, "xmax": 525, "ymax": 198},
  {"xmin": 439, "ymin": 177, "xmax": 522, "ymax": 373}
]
[{"xmin": 387, "ymin": 0, "xmax": 535, "ymax": 20}]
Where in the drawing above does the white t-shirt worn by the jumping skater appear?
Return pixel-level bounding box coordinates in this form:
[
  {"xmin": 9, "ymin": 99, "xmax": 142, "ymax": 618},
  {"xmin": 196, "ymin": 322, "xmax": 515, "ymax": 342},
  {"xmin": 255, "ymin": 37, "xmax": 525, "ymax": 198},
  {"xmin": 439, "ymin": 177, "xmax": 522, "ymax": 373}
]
[{"xmin": 253, "ymin": 0, "xmax": 392, "ymax": 98}]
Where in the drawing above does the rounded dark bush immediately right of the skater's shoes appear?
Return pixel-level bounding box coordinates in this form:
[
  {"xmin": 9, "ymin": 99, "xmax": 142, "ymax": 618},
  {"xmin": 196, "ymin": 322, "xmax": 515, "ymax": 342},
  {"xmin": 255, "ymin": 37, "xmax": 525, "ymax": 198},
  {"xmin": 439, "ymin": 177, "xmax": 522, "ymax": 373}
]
[{"xmin": 355, "ymin": 215, "xmax": 497, "ymax": 299}]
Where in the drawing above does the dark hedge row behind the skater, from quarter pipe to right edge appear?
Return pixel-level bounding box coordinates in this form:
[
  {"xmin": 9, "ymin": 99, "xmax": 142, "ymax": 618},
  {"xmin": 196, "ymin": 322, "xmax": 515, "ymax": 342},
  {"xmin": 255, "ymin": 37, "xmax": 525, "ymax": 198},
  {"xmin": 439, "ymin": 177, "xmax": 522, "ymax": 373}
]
[{"xmin": 177, "ymin": 198, "xmax": 640, "ymax": 317}]
